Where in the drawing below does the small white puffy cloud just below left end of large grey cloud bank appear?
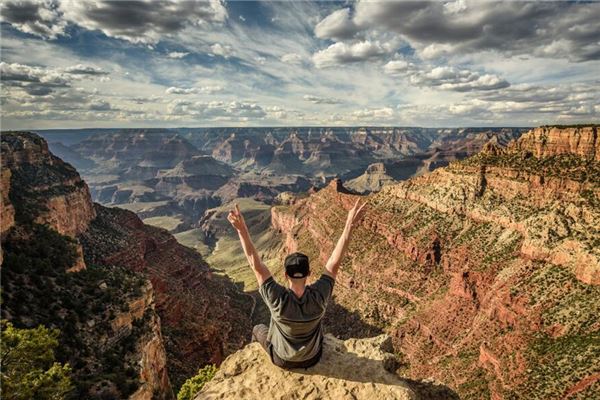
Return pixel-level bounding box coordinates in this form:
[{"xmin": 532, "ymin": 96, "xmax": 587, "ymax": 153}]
[{"xmin": 312, "ymin": 40, "xmax": 393, "ymax": 68}]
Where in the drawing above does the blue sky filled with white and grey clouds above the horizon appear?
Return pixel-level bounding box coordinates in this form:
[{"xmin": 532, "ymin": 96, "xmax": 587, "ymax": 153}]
[{"xmin": 0, "ymin": 0, "xmax": 600, "ymax": 130}]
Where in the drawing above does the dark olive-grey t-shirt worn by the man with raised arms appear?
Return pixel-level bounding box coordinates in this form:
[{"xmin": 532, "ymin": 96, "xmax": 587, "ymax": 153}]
[{"xmin": 259, "ymin": 274, "xmax": 335, "ymax": 362}]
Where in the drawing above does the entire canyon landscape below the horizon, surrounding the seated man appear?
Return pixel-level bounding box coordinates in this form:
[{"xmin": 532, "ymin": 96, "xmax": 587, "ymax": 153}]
[{"xmin": 0, "ymin": 125, "xmax": 600, "ymax": 399}]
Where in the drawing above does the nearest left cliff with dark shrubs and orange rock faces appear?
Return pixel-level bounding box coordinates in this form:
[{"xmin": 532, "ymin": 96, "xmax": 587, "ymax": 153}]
[{"xmin": 1, "ymin": 133, "xmax": 173, "ymax": 399}]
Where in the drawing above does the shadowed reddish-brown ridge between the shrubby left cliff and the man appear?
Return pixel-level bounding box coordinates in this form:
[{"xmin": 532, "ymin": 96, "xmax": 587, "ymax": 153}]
[{"xmin": 79, "ymin": 205, "xmax": 252, "ymax": 385}]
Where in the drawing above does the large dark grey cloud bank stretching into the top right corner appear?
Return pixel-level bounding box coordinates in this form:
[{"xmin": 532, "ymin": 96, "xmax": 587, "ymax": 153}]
[{"xmin": 317, "ymin": 0, "xmax": 600, "ymax": 61}]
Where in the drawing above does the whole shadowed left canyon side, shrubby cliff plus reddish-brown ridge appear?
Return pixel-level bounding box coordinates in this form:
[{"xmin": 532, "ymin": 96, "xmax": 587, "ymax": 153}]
[{"xmin": 1, "ymin": 133, "xmax": 254, "ymax": 399}]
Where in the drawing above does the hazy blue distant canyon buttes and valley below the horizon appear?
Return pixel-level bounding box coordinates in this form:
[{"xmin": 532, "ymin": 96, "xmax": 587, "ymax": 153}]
[{"xmin": 39, "ymin": 127, "xmax": 525, "ymax": 233}]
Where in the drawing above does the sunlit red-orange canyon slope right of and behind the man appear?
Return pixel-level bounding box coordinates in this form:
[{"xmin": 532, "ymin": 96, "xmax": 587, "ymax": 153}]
[{"xmin": 272, "ymin": 127, "xmax": 600, "ymax": 399}]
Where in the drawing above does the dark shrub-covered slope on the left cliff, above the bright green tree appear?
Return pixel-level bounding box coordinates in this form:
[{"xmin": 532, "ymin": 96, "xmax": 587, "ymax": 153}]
[{"xmin": 0, "ymin": 225, "xmax": 151, "ymax": 398}]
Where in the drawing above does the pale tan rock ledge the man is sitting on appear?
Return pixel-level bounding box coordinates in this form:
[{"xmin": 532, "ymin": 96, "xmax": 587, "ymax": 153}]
[{"xmin": 195, "ymin": 335, "xmax": 458, "ymax": 400}]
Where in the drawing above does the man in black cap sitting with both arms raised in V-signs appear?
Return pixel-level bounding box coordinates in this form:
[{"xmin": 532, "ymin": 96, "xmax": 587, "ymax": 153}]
[{"xmin": 227, "ymin": 200, "xmax": 366, "ymax": 368}]
